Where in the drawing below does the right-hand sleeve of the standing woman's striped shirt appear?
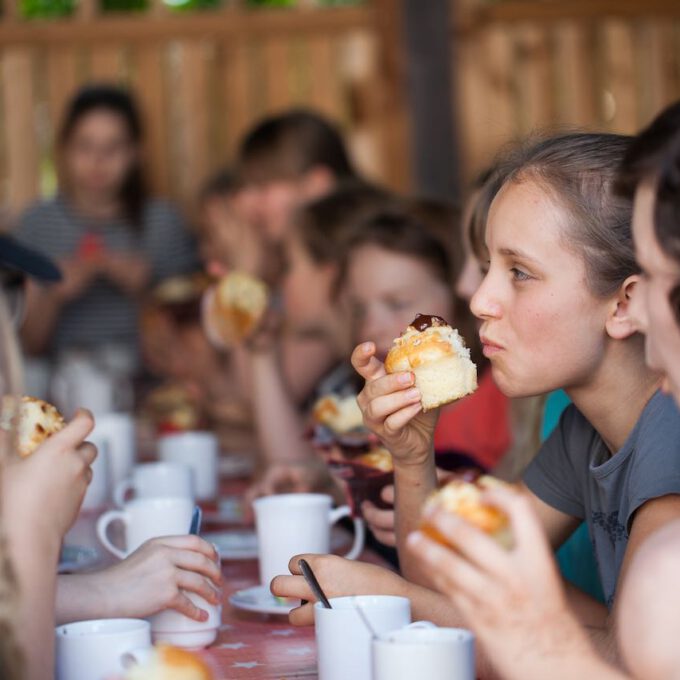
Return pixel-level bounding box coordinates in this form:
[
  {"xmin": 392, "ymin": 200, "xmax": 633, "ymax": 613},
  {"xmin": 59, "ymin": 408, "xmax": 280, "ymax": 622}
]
[{"xmin": 146, "ymin": 201, "xmax": 198, "ymax": 282}]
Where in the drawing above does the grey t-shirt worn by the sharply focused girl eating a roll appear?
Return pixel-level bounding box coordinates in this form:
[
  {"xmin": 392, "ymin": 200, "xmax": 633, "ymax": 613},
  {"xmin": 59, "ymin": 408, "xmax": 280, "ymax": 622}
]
[{"xmin": 524, "ymin": 392, "xmax": 680, "ymax": 607}]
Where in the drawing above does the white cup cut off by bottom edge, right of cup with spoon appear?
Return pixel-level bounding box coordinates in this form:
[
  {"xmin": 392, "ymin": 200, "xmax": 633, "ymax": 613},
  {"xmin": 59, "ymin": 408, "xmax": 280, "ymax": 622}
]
[{"xmin": 373, "ymin": 628, "xmax": 475, "ymax": 680}]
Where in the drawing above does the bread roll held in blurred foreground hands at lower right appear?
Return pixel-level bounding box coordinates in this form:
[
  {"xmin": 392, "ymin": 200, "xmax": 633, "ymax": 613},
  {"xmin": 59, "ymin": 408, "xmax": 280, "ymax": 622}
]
[{"xmin": 422, "ymin": 475, "xmax": 512, "ymax": 548}]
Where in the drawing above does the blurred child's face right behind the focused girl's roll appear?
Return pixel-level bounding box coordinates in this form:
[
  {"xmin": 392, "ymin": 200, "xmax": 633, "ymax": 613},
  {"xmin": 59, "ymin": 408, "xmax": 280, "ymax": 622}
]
[{"xmin": 345, "ymin": 245, "xmax": 455, "ymax": 359}]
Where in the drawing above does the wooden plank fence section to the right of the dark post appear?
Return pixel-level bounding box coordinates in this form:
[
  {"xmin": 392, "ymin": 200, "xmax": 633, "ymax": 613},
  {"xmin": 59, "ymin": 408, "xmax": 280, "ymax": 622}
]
[{"xmin": 452, "ymin": 0, "xmax": 680, "ymax": 180}]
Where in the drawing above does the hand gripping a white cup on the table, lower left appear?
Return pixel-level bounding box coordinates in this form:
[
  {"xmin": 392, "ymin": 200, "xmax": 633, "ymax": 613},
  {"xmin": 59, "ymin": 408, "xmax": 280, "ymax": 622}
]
[{"xmin": 82, "ymin": 535, "xmax": 222, "ymax": 621}]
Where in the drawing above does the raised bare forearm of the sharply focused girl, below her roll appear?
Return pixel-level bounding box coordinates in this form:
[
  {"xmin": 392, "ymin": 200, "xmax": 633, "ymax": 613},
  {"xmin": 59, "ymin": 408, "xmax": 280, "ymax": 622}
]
[{"xmin": 394, "ymin": 455, "xmax": 437, "ymax": 585}]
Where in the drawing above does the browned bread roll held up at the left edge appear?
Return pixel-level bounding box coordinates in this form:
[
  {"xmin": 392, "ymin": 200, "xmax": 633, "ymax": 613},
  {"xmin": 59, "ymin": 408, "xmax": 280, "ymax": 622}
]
[{"xmin": 0, "ymin": 396, "xmax": 64, "ymax": 457}]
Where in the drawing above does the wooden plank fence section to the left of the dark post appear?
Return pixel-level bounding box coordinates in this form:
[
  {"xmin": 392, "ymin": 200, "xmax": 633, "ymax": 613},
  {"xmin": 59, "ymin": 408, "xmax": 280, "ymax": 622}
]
[{"xmin": 0, "ymin": 0, "xmax": 408, "ymax": 212}]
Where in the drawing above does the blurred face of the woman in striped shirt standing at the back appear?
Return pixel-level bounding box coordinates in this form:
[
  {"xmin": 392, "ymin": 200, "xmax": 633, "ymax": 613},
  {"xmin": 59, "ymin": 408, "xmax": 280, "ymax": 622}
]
[{"xmin": 64, "ymin": 109, "xmax": 137, "ymax": 197}]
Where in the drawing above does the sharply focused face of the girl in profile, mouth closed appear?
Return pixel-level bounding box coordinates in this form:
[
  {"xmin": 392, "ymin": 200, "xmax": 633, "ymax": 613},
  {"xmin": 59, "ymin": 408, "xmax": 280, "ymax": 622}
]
[{"xmin": 470, "ymin": 181, "xmax": 612, "ymax": 397}]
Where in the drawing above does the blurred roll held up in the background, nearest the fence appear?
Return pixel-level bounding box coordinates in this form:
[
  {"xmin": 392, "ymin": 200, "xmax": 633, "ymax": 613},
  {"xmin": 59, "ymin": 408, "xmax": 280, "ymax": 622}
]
[{"xmin": 212, "ymin": 272, "xmax": 269, "ymax": 345}]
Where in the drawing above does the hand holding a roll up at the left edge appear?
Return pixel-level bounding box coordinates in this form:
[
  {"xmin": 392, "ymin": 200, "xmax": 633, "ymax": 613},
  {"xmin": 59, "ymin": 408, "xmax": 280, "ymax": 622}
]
[{"xmin": 2, "ymin": 411, "xmax": 97, "ymax": 543}]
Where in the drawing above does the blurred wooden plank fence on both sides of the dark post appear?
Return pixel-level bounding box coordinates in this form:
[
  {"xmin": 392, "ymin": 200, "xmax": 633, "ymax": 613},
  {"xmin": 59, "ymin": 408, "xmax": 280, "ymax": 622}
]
[{"xmin": 0, "ymin": 0, "xmax": 680, "ymax": 211}]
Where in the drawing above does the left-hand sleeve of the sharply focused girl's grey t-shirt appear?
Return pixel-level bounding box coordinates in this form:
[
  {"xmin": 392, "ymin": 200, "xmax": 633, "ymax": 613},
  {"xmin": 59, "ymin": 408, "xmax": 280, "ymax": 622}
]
[{"xmin": 524, "ymin": 405, "xmax": 587, "ymax": 519}]
